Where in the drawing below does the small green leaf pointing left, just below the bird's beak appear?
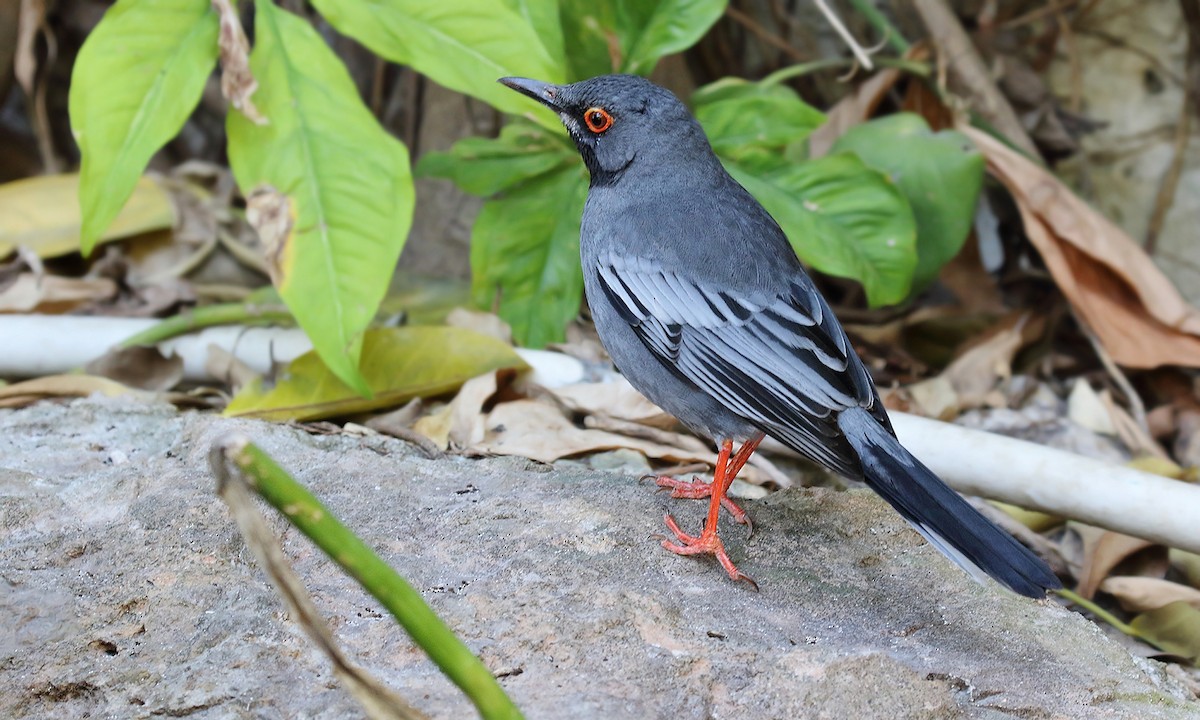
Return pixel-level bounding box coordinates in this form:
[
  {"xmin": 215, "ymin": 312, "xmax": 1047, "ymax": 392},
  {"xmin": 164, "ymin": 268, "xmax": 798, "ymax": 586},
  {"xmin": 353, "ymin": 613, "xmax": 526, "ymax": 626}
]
[{"xmin": 416, "ymin": 122, "xmax": 580, "ymax": 197}]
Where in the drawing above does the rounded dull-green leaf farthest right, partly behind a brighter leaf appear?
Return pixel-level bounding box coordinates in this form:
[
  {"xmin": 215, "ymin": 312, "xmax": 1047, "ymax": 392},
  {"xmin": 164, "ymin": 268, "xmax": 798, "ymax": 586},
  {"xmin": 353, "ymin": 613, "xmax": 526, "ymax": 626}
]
[{"xmin": 833, "ymin": 113, "xmax": 984, "ymax": 292}]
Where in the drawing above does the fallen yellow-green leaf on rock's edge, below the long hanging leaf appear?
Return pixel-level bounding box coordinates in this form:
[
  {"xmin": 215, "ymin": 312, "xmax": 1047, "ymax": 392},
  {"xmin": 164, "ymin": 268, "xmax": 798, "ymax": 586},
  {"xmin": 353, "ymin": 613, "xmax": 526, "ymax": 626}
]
[{"xmin": 224, "ymin": 326, "xmax": 526, "ymax": 420}]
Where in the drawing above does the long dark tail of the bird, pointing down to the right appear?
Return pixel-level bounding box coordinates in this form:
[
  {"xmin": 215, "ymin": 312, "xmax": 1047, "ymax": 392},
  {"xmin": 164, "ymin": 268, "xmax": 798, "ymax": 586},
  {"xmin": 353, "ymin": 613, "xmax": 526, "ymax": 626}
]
[{"xmin": 838, "ymin": 408, "xmax": 1062, "ymax": 598}]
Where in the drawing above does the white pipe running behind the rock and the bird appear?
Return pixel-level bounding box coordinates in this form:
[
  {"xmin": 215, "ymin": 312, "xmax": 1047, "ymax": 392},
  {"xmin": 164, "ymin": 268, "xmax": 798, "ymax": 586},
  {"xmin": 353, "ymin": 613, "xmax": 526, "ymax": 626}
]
[{"xmin": 0, "ymin": 316, "xmax": 1200, "ymax": 553}]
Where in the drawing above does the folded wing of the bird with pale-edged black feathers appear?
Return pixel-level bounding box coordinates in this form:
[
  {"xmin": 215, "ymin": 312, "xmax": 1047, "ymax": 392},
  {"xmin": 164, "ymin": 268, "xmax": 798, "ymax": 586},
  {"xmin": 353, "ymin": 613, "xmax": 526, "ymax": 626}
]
[{"xmin": 596, "ymin": 254, "xmax": 890, "ymax": 476}]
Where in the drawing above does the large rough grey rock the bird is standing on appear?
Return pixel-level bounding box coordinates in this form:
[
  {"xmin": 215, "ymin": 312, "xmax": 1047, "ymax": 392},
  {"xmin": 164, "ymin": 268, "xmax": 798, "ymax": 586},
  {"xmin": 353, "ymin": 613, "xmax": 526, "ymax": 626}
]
[{"xmin": 0, "ymin": 401, "xmax": 1200, "ymax": 720}]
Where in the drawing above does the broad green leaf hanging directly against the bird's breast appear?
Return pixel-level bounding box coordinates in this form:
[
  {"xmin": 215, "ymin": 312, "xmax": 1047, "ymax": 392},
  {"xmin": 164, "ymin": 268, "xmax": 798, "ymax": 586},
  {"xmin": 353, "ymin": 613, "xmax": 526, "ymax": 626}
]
[{"xmin": 470, "ymin": 163, "xmax": 588, "ymax": 348}]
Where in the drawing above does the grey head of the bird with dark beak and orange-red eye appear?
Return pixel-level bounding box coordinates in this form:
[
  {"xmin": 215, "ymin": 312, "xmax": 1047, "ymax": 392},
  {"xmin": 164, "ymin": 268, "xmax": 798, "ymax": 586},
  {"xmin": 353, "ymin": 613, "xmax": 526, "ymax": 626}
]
[{"xmin": 500, "ymin": 74, "xmax": 712, "ymax": 185}]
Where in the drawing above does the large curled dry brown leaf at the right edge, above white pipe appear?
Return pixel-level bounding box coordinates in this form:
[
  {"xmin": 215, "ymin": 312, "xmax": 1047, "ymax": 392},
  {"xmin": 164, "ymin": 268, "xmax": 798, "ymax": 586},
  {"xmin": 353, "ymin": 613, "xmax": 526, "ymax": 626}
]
[{"xmin": 959, "ymin": 126, "xmax": 1200, "ymax": 367}]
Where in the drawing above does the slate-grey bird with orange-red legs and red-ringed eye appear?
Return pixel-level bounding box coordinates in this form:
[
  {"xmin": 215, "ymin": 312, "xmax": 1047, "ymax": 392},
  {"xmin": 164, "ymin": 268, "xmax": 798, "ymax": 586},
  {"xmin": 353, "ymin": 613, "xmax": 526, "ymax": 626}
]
[{"xmin": 499, "ymin": 74, "xmax": 1061, "ymax": 598}]
